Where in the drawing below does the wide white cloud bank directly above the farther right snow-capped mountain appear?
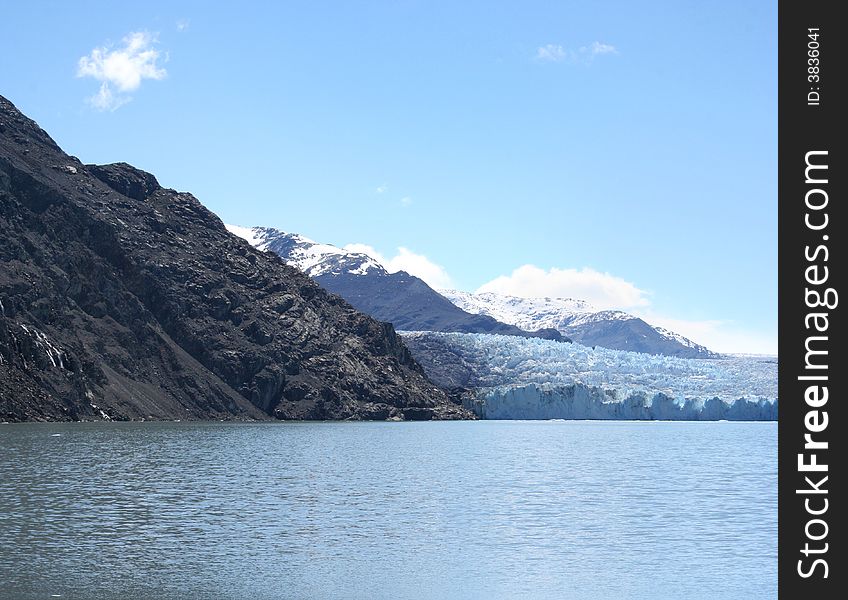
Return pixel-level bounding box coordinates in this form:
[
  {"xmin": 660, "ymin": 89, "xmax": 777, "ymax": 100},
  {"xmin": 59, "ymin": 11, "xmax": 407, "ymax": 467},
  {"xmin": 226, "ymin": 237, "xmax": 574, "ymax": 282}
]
[{"xmin": 477, "ymin": 265, "xmax": 648, "ymax": 309}]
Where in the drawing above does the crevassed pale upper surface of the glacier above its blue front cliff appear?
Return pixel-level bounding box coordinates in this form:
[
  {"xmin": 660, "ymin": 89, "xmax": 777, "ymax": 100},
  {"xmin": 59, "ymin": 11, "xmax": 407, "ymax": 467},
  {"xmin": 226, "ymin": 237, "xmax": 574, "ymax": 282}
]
[{"xmin": 403, "ymin": 332, "xmax": 777, "ymax": 418}]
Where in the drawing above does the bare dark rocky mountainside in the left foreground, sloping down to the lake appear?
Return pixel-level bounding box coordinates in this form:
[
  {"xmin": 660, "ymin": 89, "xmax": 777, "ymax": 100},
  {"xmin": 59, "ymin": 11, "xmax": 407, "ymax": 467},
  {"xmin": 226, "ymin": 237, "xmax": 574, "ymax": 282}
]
[{"xmin": 0, "ymin": 97, "xmax": 468, "ymax": 421}]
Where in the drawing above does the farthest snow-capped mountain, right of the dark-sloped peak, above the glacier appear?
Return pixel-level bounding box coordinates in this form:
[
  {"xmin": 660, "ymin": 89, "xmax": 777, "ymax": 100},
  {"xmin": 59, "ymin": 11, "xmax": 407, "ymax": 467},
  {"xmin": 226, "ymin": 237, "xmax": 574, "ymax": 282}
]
[{"xmin": 439, "ymin": 290, "xmax": 717, "ymax": 358}]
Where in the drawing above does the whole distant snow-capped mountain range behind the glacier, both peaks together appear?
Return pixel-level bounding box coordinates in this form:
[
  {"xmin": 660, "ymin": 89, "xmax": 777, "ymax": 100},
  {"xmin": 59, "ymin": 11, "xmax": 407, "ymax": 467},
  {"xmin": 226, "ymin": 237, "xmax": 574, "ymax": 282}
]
[{"xmin": 227, "ymin": 225, "xmax": 717, "ymax": 358}]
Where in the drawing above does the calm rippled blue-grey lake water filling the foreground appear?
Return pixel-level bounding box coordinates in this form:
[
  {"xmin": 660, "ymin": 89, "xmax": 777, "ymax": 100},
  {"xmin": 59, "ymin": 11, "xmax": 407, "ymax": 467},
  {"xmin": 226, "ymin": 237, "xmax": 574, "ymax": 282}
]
[{"xmin": 0, "ymin": 421, "xmax": 777, "ymax": 600}]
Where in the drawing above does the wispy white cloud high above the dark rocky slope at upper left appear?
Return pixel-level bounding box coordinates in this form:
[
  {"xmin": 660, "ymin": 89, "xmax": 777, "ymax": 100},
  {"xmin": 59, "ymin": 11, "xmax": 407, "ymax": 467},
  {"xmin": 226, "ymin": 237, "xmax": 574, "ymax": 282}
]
[{"xmin": 77, "ymin": 31, "xmax": 167, "ymax": 110}]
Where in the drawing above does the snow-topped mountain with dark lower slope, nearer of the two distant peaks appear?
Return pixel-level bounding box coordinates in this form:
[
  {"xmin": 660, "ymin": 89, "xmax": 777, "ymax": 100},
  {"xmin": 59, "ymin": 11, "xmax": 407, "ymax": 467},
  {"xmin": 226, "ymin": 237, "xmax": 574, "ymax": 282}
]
[{"xmin": 228, "ymin": 225, "xmax": 570, "ymax": 341}]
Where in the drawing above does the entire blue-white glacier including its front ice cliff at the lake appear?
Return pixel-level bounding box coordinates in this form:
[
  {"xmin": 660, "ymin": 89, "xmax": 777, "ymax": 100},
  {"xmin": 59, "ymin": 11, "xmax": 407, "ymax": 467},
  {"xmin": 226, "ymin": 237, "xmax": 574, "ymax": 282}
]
[{"xmin": 402, "ymin": 332, "xmax": 778, "ymax": 421}]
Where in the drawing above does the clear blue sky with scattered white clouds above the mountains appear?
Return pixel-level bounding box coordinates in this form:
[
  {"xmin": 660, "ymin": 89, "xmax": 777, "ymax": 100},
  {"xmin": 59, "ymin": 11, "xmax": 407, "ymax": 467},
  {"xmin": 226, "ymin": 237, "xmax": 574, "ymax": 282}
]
[{"xmin": 0, "ymin": 0, "xmax": 777, "ymax": 352}]
